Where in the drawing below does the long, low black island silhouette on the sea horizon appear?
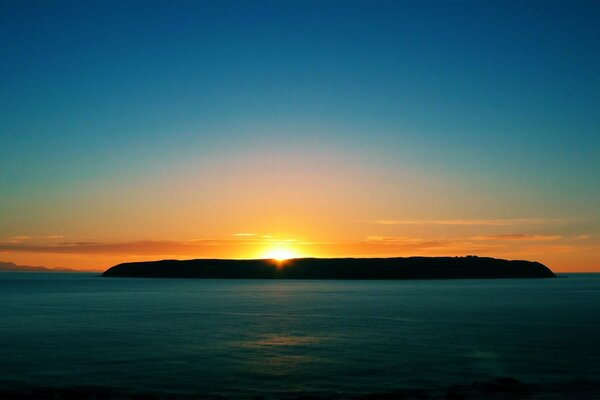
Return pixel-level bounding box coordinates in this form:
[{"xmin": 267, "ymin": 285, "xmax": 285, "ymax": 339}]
[{"xmin": 102, "ymin": 256, "xmax": 556, "ymax": 280}]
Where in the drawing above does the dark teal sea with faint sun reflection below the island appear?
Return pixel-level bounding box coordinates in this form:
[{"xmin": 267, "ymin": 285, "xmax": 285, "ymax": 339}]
[{"xmin": 0, "ymin": 273, "xmax": 600, "ymax": 398}]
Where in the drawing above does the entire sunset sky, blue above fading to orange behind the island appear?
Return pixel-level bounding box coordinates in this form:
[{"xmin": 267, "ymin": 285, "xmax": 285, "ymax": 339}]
[{"xmin": 0, "ymin": 0, "xmax": 600, "ymax": 272}]
